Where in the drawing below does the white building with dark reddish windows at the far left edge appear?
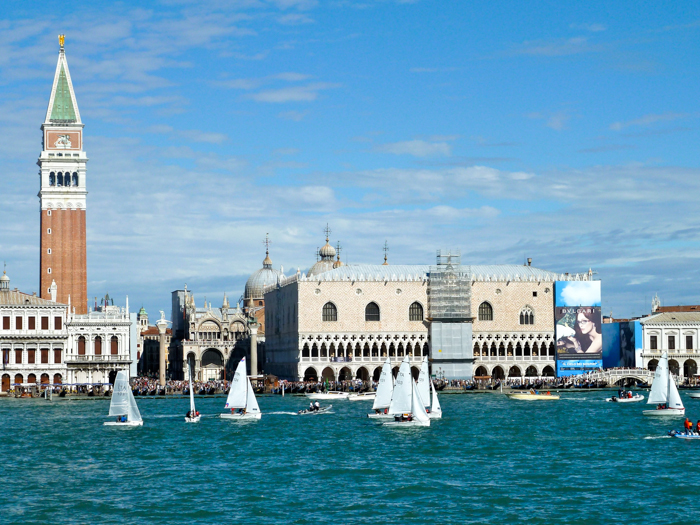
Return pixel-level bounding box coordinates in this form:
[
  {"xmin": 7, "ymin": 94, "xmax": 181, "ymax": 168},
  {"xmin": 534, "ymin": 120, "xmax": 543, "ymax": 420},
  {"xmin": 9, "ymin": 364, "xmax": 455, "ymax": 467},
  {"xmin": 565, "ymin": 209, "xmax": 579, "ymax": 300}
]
[{"xmin": 0, "ymin": 272, "xmax": 69, "ymax": 392}]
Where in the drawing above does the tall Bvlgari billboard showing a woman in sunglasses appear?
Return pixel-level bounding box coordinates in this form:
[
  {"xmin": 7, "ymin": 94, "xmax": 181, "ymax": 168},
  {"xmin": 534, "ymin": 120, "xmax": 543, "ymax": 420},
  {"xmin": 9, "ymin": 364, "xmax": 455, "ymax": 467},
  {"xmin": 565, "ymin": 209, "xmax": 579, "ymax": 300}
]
[{"xmin": 554, "ymin": 281, "xmax": 603, "ymax": 377}]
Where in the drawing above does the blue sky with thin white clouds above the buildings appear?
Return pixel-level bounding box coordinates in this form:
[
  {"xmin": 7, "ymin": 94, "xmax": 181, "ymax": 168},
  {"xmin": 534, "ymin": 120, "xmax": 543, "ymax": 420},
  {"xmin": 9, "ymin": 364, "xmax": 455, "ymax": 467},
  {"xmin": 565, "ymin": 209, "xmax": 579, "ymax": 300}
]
[{"xmin": 0, "ymin": 0, "xmax": 700, "ymax": 317}]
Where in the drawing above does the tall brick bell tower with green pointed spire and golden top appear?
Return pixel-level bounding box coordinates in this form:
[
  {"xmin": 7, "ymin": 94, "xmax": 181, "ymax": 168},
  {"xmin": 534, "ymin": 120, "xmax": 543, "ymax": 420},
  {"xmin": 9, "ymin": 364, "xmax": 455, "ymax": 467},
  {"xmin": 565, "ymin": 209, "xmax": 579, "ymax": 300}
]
[{"xmin": 37, "ymin": 35, "xmax": 88, "ymax": 314}]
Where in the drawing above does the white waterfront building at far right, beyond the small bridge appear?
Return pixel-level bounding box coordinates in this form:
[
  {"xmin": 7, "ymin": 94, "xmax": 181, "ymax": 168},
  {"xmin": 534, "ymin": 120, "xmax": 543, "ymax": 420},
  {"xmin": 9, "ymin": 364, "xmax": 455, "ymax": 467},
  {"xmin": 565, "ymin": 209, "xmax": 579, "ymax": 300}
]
[{"xmin": 639, "ymin": 311, "xmax": 700, "ymax": 380}]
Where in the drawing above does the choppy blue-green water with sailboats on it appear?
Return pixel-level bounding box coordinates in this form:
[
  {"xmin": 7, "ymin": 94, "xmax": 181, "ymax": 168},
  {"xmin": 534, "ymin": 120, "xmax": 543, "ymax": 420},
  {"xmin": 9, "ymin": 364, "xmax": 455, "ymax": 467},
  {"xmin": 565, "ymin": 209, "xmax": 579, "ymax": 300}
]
[{"xmin": 0, "ymin": 392, "xmax": 700, "ymax": 524}]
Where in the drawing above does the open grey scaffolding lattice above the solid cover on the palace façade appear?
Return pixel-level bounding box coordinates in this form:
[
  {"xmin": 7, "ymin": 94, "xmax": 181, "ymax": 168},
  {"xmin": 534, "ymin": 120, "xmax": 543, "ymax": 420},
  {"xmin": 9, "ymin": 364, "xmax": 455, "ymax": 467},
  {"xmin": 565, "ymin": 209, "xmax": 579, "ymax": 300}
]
[{"xmin": 428, "ymin": 250, "xmax": 471, "ymax": 322}]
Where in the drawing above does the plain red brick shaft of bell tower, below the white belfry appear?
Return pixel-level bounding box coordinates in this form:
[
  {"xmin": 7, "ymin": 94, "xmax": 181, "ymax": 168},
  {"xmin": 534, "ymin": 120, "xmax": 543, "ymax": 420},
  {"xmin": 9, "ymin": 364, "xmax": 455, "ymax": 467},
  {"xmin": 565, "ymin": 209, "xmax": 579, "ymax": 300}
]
[{"xmin": 39, "ymin": 210, "xmax": 87, "ymax": 314}]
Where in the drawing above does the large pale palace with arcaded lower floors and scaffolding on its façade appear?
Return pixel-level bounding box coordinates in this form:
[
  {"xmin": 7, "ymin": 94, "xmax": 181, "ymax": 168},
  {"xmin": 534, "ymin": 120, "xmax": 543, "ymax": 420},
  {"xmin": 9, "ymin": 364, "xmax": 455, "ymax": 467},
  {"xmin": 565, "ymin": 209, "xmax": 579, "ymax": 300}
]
[{"xmin": 264, "ymin": 229, "xmax": 592, "ymax": 380}]
